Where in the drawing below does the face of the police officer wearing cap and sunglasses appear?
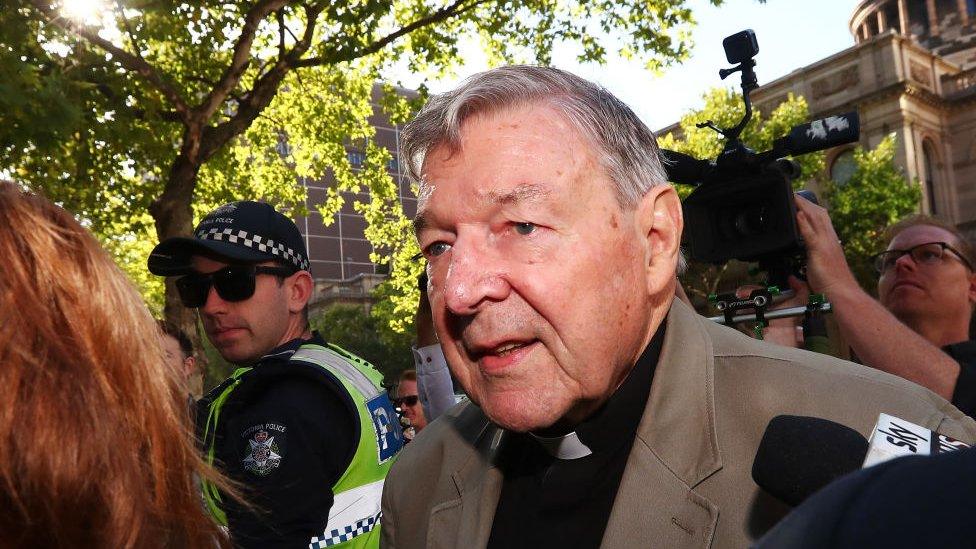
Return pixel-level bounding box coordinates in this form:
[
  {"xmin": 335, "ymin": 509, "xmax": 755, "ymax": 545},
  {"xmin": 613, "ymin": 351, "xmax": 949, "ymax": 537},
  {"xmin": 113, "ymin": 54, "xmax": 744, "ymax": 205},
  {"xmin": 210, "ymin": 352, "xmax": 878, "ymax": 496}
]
[{"xmin": 193, "ymin": 256, "xmax": 290, "ymax": 364}]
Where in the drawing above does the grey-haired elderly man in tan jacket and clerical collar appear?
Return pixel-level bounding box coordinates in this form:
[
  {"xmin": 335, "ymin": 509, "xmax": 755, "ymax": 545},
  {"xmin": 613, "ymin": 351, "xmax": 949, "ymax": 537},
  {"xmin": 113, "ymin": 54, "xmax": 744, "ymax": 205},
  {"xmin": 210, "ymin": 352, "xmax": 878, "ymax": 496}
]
[{"xmin": 382, "ymin": 66, "xmax": 976, "ymax": 548}]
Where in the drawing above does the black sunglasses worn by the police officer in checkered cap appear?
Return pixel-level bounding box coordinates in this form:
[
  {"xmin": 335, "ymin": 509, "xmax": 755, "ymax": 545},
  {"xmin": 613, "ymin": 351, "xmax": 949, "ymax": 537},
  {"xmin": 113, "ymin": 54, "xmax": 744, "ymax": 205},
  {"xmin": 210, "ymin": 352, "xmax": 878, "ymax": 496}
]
[{"xmin": 176, "ymin": 265, "xmax": 295, "ymax": 308}]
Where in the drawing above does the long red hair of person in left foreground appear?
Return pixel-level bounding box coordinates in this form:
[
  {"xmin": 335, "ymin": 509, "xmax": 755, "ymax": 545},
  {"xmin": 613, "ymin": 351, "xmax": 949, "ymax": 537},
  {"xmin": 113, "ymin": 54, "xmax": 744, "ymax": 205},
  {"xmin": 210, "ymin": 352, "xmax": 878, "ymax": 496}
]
[{"xmin": 0, "ymin": 181, "xmax": 234, "ymax": 548}]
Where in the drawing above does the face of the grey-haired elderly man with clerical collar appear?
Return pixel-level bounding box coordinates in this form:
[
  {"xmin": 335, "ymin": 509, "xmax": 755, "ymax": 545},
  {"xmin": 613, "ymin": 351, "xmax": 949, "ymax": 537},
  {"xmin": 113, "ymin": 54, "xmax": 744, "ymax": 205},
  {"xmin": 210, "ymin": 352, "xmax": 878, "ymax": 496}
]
[{"xmin": 416, "ymin": 105, "xmax": 681, "ymax": 431}]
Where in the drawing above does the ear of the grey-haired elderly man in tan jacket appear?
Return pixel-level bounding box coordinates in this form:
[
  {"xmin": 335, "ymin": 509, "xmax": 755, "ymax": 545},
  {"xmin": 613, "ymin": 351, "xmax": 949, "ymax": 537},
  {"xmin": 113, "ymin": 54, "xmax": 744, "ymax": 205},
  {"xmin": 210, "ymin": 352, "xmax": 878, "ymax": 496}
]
[{"xmin": 637, "ymin": 183, "xmax": 684, "ymax": 295}]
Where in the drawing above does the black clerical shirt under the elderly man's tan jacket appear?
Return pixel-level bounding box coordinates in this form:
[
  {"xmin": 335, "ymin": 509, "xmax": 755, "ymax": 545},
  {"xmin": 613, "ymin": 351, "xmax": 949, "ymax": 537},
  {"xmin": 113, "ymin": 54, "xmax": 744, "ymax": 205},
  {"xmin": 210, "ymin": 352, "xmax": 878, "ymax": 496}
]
[{"xmin": 488, "ymin": 325, "xmax": 664, "ymax": 549}]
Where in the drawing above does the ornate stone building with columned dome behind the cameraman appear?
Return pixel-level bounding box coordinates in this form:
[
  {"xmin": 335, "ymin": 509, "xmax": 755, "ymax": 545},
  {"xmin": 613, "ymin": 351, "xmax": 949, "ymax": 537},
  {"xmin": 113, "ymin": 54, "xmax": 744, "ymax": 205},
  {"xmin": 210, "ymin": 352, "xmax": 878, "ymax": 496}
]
[{"xmin": 661, "ymin": 0, "xmax": 976, "ymax": 241}]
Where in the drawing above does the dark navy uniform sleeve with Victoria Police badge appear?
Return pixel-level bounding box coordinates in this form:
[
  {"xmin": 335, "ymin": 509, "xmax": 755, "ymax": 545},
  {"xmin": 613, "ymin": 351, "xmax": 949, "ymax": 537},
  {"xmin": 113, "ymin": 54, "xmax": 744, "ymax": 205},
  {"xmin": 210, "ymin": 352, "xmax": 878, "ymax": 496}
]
[{"xmin": 200, "ymin": 334, "xmax": 359, "ymax": 548}]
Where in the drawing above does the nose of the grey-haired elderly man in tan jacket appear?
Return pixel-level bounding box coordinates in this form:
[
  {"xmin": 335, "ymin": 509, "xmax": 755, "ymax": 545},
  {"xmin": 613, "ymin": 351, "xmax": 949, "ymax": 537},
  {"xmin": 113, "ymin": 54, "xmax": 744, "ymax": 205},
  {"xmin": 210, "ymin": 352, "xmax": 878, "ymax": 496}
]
[{"xmin": 443, "ymin": 243, "xmax": 510, "ymax": 315}]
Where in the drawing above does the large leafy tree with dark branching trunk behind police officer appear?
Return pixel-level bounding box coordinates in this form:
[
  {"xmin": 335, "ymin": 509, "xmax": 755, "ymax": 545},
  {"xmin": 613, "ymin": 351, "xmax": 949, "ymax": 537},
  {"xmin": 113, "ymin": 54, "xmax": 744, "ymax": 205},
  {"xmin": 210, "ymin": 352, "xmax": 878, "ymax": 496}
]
[{"xmin": 0, "ymin": 0, "xmax": 720, "ymax": 342}]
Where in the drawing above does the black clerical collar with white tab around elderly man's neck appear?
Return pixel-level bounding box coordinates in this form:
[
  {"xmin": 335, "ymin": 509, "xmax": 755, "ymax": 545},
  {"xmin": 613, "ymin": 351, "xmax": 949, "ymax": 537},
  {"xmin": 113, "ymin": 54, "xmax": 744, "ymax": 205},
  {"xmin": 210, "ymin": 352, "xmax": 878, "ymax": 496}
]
[{"xmin": 529, "ymin": 322, "xmax": 664, "ymax": 460}]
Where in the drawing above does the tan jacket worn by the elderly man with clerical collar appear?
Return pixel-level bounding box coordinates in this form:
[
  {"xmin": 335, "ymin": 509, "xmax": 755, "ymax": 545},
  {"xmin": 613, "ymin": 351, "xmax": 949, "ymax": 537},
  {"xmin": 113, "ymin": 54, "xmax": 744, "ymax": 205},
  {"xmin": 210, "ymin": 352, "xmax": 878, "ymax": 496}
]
[{"xmin": 382, "ymin": 301, "xmax": 976, "ymax": 549}]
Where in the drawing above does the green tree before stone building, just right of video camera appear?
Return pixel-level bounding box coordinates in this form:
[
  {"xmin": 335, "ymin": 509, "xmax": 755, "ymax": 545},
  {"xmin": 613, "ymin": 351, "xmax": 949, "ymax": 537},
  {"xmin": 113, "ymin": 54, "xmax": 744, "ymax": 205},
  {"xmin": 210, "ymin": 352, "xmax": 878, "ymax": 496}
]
[{"xmin": 823, "ymin": 134, "xmax": 922, "ymax": 294}]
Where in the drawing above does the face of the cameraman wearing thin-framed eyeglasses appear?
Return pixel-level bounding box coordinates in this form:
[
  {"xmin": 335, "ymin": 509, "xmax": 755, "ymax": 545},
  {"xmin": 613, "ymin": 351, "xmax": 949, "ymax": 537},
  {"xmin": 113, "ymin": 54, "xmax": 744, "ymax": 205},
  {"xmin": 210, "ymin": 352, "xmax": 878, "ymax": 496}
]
[{"xmin": 878, "ymin": 225, "xmax": 976, "ymax": 330}]
